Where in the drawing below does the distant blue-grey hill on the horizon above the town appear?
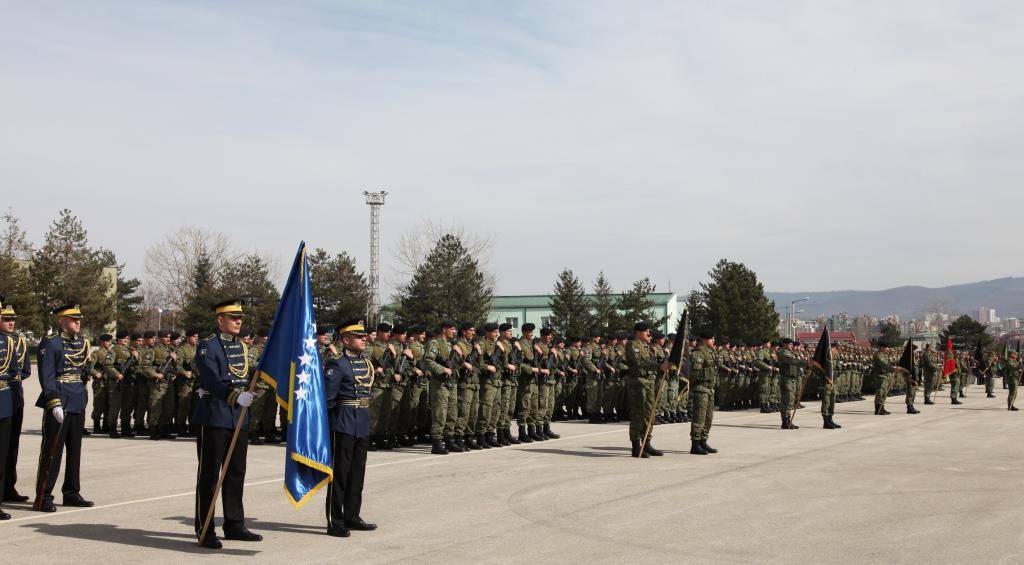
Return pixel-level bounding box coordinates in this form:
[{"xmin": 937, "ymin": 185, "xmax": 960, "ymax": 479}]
[{"xmin": 766, "ymin": 276, "xmax": 1024, "ymax": 319}]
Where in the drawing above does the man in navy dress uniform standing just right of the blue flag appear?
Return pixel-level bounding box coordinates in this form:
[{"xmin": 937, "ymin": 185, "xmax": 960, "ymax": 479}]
[{"xmin": 324, "ymin": 319, "xmax": 377, "ymax": 537}]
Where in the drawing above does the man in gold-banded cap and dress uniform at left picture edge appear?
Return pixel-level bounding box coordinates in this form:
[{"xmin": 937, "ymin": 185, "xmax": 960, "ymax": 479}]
[{"xmin": 0, "ymin": 298, "xmax": 32, "ymax": 503}]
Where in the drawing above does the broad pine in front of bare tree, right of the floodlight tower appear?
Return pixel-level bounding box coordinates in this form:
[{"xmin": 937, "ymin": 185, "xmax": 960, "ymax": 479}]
[{"xmin": 398, "ymin": 234, "xmax": 493, "ymax": 325}]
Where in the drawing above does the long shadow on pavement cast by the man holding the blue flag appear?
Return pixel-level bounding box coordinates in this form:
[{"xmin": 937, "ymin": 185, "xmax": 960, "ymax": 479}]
[{"xmin": 22, "ymin": 520, "xmax": 259, "ymax": 557}]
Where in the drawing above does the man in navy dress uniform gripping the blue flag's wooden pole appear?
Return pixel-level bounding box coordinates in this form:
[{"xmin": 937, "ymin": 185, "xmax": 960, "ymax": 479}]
[{"xmin": 193, "ymin": 300, "xmax": 263, "ymax": 550}]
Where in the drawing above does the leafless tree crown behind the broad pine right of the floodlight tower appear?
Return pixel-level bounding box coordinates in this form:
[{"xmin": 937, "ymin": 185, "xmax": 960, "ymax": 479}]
[{"xmin": 387, "ymin": 218, "xmax": 496, "ymax": 299}]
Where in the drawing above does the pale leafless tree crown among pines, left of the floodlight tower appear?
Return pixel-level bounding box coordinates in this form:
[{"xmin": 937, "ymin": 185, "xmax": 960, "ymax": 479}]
[{"xmin": 145, "ymin": 225, "xmax": 244, "ymax": 310}]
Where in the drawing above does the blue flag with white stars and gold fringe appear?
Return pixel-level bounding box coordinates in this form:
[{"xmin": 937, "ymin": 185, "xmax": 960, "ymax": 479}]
[{"xmin": 257, "ymin": 242, "xmax": 334, "ymax": 508}]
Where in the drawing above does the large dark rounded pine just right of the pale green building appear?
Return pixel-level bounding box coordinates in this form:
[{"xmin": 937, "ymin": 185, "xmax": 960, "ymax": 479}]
[{"xmin": 700, "ymin": 259, "xmax": 778, "ymax": 343}]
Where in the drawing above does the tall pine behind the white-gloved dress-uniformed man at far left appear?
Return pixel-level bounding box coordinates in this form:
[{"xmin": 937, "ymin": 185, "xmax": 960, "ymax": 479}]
[{"xmin": 29, "ymin": 209, "xmax": 117, "ymax": 336}]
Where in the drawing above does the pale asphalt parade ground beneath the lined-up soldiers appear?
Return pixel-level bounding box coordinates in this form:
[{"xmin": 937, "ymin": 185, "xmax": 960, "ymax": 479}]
[{"xmin": 0, "ymin": 380, "xmax": 1024, "ymax": 565}]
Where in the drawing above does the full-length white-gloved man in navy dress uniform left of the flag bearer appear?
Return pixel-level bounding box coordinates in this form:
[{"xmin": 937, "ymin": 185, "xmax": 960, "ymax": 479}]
[{"xmin": 33, "ymin": 304, "xmax": 92, "ymax": 512}]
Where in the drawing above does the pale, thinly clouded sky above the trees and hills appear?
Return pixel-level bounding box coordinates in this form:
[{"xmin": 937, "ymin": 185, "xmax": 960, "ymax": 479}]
[{"xmin": 0, "ymin": 1, "xmax": 1024, "ymax": 294}]
